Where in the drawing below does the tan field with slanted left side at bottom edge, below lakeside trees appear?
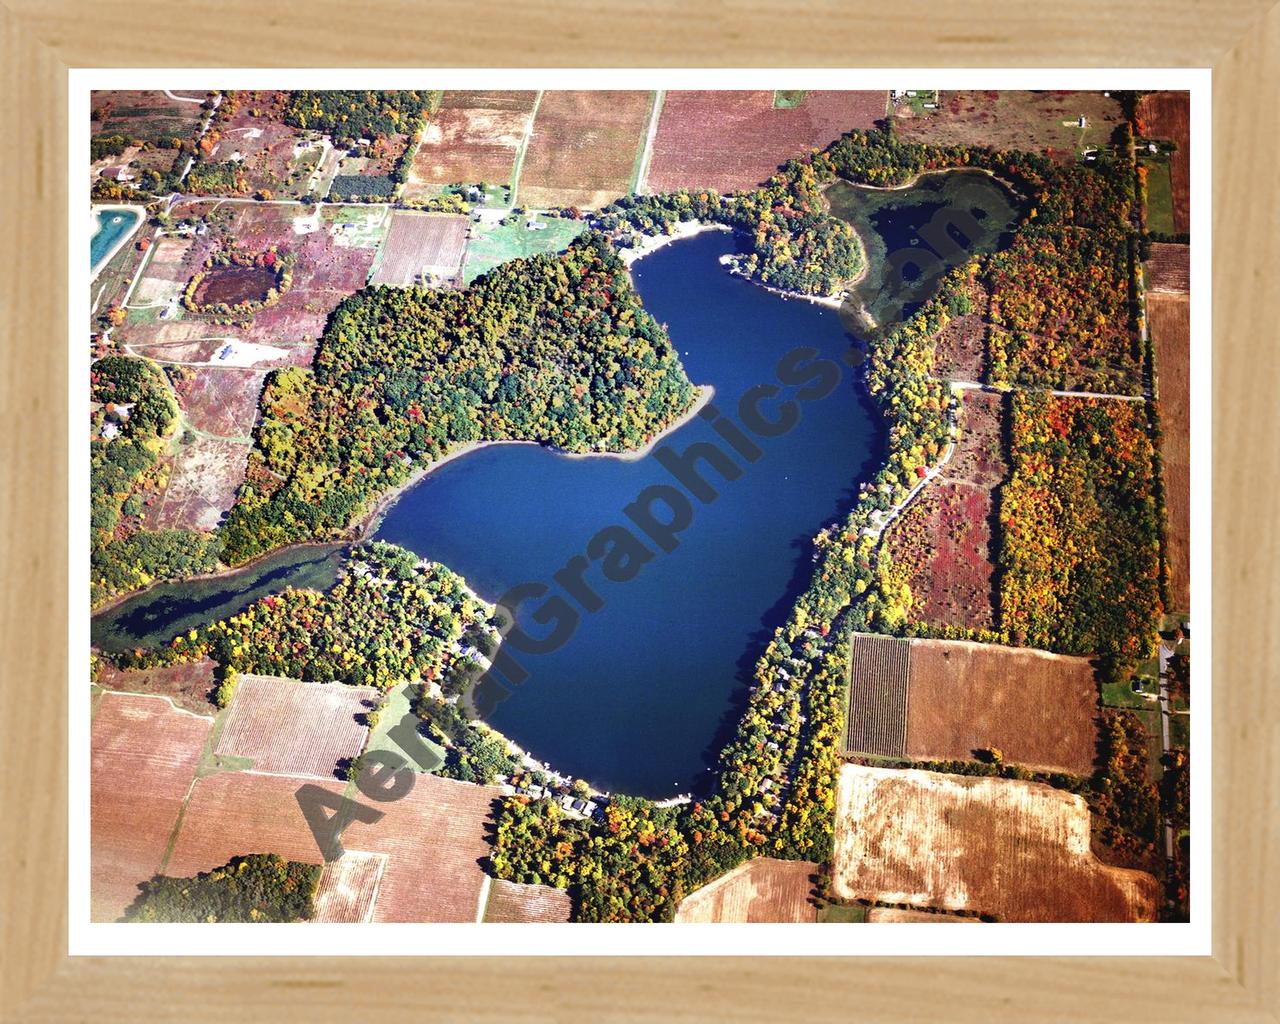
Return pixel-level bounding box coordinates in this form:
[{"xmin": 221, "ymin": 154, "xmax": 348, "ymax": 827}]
[{"xmin": 676, "ymin": 858, "xmax": 818, "ymax": 924}]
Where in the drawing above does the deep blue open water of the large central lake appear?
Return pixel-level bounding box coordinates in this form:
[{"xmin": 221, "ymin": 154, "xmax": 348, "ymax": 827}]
[{"xmin": 376, "ymin": 233, "xmax": 884, "ymax": 797}]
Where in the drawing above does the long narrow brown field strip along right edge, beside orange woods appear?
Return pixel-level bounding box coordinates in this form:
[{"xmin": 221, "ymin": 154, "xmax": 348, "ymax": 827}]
[{"xmin": 1147, "ymin": 292, "xmax": 1192, "ymax": 612}]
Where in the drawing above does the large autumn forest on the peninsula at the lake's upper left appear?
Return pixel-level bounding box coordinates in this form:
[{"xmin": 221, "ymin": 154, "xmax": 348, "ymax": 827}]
[{"xmin": 223, "ymin": 234, "xmax": 694, "ymax": 564}]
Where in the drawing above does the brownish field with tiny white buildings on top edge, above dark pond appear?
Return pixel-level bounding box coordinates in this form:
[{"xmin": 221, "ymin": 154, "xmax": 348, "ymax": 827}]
[{"xmin": 893, "ymin": 90, "xmax": 1124, "ymax": 161}]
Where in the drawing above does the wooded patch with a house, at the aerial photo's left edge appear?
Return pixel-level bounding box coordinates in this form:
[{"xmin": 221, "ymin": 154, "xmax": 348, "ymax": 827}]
[{"xmin": 90, "ymin": 356, "xmax": 218, "ymax": 607}]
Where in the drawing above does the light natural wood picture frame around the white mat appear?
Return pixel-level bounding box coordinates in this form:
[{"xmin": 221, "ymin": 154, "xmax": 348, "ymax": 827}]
[{"xmin": 0, "ymin": 0, "xmax": 1280, "ymax": 1021}]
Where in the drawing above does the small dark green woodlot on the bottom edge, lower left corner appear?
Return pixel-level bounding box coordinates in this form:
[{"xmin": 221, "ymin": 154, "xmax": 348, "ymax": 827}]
[{"xmin": 124, "ymin": 854, "xmax": 320, "ymax": 924}]
